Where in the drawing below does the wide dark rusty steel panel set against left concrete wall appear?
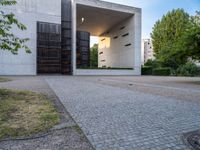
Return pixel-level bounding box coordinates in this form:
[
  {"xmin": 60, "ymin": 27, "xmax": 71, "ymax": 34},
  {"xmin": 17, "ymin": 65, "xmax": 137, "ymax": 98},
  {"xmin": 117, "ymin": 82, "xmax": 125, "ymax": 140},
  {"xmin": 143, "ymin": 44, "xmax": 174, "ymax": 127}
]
[{"xmin": 37, "ymin": 22, "xmax": 61, "ymax": 73}]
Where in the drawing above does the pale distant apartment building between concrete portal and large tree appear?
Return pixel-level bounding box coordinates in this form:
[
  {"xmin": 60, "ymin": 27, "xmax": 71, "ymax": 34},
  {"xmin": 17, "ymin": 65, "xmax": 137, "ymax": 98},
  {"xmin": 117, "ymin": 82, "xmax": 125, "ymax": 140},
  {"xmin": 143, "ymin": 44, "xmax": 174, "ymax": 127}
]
[{"xmin": 142, "ymin": 39, "xmax": 154, "ymax": 64}]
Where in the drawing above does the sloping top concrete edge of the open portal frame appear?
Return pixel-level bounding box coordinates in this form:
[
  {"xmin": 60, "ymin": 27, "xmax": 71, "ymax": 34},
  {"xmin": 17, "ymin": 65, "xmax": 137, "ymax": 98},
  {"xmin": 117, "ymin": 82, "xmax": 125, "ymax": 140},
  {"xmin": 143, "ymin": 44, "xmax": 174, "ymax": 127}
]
[{"xmin": 74, "ymin": 0, "xmax": 142, "ymax": 14}]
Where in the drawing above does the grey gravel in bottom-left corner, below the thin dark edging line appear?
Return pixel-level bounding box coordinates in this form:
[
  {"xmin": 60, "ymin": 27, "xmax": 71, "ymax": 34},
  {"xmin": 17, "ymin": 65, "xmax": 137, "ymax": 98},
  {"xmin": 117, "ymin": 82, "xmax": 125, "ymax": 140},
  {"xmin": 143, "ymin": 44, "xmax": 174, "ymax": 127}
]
[{"xmin": 0, "ymin": 128, "xmax": 92, "ymax": 150}]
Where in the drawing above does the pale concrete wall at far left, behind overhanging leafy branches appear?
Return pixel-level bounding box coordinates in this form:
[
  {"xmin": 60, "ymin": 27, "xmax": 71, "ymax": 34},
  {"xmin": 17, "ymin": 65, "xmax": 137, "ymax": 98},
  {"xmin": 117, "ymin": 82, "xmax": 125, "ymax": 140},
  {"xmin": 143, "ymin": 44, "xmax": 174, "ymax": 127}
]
[{"xmin": 0, "ymin": 0, "xmax": 61, "ymax": 75}]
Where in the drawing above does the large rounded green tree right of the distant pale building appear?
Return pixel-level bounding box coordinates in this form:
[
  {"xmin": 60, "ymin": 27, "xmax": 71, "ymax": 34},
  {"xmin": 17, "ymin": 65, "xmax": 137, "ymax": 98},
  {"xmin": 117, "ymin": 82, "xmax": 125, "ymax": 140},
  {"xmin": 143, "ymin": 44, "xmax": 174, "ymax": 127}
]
[{"xmin": 151, "ymin": 9, "xmax": 190, "ymax": 69}]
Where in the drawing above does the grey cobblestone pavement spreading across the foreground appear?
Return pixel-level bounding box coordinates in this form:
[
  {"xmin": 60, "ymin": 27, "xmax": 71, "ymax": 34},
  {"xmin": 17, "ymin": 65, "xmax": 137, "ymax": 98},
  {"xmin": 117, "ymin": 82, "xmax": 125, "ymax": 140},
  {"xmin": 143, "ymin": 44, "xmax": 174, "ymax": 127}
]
[{"xmin": 45, "ymin": 76, "xmax": 200, "ymax": 150}]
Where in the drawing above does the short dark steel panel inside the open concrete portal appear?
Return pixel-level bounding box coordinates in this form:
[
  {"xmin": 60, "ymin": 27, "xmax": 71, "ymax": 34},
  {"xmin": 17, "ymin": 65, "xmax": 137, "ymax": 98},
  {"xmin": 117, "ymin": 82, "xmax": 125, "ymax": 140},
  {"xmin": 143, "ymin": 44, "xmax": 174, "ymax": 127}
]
[{"xmin": 76, "ymin": 31, "xmax": 90, "ymax": 68}]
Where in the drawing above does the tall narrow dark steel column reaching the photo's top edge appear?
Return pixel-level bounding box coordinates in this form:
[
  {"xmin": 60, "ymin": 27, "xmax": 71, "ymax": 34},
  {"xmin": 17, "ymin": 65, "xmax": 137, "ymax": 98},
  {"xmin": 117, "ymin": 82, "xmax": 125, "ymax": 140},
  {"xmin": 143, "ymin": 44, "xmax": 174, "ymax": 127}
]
[{"xmin": 61, "ymin": 0, "xmax": 72, "ymax": 75}]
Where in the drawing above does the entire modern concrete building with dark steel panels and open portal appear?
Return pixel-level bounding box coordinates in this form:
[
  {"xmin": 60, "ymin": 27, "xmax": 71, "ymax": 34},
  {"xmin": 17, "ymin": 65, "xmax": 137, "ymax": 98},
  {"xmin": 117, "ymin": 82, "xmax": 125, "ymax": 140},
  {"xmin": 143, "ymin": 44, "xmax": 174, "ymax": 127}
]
[{"xmin": 0, "ymin": 0, "xmax": 141, "ymax": 75}]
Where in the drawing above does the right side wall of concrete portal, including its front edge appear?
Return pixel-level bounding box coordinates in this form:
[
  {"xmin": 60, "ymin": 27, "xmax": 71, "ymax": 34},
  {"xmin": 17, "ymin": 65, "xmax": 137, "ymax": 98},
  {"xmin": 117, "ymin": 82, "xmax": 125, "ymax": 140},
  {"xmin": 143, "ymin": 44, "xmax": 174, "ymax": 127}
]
[{"xmin": 98, "ymin": 12, "xmax": 142, "ymax": 75}]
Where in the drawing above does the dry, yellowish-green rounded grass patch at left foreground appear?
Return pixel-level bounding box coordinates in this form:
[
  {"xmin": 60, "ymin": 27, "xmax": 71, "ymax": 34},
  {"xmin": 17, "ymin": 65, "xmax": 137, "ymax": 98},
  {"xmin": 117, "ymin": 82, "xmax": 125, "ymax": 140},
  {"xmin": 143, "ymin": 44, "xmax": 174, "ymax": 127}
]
[{"xmin": 0, "ymin": 89, "xmax": 59, "ymax": 139}]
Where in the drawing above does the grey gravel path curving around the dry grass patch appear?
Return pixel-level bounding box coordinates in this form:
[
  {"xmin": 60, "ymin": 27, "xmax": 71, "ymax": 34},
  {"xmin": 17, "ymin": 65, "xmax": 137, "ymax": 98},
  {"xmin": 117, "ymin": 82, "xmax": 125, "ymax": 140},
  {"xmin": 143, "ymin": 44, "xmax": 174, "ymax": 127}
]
[{"xmin": 0, "ymin": 76, "xmax": 93, "ymax": 150}]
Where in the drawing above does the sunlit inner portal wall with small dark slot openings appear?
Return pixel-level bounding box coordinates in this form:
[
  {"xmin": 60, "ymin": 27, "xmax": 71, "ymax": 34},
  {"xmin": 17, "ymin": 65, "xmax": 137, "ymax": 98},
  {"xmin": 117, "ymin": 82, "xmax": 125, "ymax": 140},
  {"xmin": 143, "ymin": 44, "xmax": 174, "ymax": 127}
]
[{"xmin": 98, "ymin": 16, "xmax": 135, "ymax": 68}]
